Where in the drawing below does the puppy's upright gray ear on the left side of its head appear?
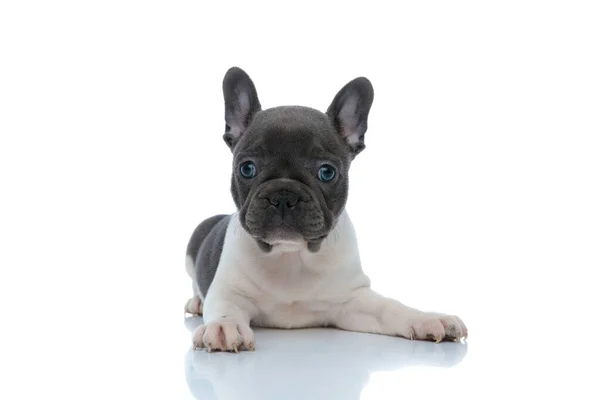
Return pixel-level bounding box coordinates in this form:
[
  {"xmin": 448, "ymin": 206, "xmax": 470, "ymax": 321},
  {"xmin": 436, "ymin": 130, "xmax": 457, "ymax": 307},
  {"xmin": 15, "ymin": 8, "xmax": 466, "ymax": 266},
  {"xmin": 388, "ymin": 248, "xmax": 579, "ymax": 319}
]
[{"xmin": 223, "ymin": 67, "xmax": 260, "ymax": 150}]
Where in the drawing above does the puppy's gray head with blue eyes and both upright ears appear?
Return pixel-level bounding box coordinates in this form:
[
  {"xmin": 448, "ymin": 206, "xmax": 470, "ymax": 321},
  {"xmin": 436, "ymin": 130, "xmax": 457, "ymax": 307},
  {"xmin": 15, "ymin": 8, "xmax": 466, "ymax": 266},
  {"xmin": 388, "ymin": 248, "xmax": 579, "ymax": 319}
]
[{"xmin": 223, "ymin": 68, "xmax": 373, "ymax": 251}]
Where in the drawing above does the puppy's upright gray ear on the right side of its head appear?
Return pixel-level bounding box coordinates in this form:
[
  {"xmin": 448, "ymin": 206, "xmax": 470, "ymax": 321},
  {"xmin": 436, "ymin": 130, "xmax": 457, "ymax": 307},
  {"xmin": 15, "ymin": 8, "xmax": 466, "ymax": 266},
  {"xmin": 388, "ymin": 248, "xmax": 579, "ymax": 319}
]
[{"xmin": 327, "ymin": 77, "xmax": 374, "ymax": 157}]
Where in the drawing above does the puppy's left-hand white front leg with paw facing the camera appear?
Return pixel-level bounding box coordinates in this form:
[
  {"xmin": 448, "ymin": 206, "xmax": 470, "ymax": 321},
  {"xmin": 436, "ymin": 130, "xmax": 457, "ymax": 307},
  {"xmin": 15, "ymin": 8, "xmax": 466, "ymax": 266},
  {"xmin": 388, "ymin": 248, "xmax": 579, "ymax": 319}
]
[{"xmin": 193, "ymin": 290, "xmax": 254, "ymax": 353}]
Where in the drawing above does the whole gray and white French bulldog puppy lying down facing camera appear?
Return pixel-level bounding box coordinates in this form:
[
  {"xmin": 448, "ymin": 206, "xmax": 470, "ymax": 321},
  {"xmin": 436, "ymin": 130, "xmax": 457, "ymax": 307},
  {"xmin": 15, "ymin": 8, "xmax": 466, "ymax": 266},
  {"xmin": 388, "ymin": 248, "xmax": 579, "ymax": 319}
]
[{"xmin": 185, "ymin": 67, "xmax": 467, "ymax": 352}]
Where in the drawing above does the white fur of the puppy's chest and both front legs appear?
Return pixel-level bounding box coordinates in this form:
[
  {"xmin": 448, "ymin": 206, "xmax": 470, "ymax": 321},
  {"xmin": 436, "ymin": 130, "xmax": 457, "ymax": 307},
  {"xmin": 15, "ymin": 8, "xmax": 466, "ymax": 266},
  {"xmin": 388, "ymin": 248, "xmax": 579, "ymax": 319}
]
[{"xmin": 193, "ymin": 211, "xmax": 467, "ymax": 351}]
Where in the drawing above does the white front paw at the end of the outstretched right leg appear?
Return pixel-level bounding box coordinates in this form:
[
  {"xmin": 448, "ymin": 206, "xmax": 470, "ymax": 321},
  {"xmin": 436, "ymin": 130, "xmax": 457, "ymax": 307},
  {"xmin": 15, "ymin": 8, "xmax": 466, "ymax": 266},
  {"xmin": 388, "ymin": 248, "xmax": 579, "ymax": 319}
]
[{"xmin": 403, "ymin": 313, "xmax": 469, "ymax": 343}]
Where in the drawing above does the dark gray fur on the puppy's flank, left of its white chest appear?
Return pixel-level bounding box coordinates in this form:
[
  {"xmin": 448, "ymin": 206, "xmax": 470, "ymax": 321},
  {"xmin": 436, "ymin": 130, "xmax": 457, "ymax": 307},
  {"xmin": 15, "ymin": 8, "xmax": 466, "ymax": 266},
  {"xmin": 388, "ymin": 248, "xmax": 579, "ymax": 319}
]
[{"xmin": 186, "ymin": 215, "xmax": 231, "ymax": 297}]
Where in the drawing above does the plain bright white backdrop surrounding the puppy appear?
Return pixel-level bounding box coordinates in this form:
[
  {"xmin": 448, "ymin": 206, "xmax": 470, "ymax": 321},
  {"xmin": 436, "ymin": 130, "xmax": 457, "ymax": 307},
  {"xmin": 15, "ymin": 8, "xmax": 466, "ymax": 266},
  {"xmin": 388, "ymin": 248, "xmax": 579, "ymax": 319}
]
[{"xmin": 0, "ymin": 1, "xmax": 600, "ymax": 399}]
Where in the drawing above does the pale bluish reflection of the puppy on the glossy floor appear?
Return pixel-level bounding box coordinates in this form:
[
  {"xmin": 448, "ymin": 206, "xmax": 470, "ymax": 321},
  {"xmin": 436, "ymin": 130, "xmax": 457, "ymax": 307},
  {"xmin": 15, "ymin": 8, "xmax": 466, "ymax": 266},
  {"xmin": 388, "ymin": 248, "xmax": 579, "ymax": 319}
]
[{"xmin": 185, "ymin": 317, "xmax": 467, "ymax": 400}]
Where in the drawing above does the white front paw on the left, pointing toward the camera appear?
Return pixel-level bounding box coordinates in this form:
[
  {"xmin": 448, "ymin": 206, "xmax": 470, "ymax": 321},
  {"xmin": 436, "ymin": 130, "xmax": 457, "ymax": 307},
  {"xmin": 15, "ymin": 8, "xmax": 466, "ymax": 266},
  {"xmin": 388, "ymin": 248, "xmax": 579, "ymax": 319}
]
[{"xmin": 193, "ymin": 319, "xmax": 254, "ymax": 353}]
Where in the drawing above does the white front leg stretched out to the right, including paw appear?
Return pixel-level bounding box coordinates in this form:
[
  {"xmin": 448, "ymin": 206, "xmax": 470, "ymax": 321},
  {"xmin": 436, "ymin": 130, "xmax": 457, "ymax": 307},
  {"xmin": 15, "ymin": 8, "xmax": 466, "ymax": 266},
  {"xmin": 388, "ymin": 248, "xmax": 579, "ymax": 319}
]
[{"xmin": 333, "ymin": 288, "xmax": 468, "ymax": 342}]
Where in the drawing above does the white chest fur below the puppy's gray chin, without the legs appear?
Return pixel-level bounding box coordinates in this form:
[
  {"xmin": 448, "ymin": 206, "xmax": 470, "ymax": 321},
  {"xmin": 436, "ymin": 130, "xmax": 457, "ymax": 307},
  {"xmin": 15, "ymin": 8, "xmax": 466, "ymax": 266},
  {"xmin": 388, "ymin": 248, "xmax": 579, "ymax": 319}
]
[{"xmin": 206, "ymin": 211, "xmax": 369, "ymax": 328}]
